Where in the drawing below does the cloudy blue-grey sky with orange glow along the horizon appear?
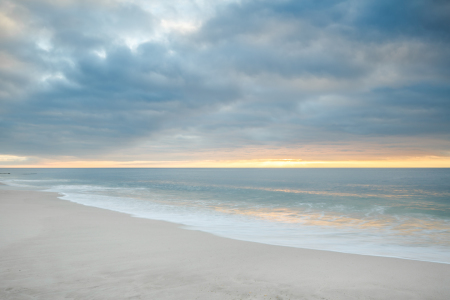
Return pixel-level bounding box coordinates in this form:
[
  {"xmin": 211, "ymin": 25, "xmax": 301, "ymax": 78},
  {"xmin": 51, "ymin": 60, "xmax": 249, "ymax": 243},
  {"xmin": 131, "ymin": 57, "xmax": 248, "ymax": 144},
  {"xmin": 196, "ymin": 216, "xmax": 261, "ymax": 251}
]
[{"xmin": 0, "ymin": 0, "xmax": 450, "ymax": 167}]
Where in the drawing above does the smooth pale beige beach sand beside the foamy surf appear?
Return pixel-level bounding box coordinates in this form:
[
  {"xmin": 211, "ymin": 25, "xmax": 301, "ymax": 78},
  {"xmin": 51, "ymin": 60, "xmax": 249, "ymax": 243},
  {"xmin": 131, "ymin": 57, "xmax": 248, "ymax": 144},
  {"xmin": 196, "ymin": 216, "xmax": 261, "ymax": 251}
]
[{"xmin": 0, "ymin": 187, "xmax": 450, "ymax": 300}]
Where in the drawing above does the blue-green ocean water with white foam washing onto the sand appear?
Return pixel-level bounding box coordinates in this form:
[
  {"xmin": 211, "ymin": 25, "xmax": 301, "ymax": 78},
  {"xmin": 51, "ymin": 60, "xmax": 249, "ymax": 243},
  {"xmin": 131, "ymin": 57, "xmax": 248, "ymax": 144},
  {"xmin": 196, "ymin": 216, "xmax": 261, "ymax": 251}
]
[{"xmin": 0, "ymin": 168, "xmax": 450, "ymax": 263}]
